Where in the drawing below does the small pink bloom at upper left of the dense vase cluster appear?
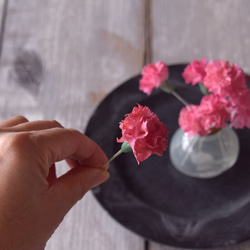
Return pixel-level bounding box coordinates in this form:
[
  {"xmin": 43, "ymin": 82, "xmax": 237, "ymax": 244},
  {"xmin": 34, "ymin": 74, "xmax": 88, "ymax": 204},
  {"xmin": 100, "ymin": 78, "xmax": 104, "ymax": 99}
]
[{"xmin": 182, "ymin": 58, "xmax": 207, "ymax": 85}]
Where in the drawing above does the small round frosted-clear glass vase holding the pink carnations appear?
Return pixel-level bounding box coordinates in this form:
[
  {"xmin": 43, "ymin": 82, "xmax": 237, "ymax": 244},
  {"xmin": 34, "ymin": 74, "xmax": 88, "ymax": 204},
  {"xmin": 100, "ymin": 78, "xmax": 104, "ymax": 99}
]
[{"xmin": 169, "ymin": 127, "xmax": 239, "ymax": 178}]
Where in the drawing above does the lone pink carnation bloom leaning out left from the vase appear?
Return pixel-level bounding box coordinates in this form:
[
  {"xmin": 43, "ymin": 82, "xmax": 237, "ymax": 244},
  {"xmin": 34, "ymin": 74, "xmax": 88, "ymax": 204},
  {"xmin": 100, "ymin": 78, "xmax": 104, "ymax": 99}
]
[{"xmin": 139, "ymin": 62, "xmax": 169, "ymax": 95}]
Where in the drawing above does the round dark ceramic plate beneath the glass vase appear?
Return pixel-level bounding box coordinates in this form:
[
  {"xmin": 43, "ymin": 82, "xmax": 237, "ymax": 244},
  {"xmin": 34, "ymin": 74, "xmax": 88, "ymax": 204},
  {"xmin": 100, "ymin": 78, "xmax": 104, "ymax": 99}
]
[{"xmin": 85, "ymin": 65, "xmax": 250, "ymax": 248}]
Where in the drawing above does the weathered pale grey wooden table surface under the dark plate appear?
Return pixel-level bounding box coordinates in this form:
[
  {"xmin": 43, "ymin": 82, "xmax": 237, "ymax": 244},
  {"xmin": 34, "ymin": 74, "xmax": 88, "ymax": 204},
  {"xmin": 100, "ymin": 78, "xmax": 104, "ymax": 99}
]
[{"xmin": 0, "ymin": 0, "xmax": 250, "ymax": 250}]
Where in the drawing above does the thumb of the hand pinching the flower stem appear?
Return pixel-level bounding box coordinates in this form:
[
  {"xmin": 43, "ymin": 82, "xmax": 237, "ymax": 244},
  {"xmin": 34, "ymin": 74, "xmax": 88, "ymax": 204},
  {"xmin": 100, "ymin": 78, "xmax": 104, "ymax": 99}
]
[{"xmin": 47, "ymin": 167, "xmax": 109, "ymax": 214}]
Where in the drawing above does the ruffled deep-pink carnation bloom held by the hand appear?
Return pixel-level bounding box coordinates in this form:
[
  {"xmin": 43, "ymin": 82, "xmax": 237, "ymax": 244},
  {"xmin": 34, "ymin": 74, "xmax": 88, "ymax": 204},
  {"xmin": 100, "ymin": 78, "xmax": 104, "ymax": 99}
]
[{"xmin": 117, "ymin": 105, "xmax": 168, "ymax": 164}]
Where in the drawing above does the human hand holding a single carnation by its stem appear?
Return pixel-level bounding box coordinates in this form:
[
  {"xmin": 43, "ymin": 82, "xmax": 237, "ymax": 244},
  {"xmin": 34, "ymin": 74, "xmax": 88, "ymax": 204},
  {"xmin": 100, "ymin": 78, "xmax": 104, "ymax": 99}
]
[{"xmin": 0, "ymin": 116, "xmax": 109, "ymax": 250}]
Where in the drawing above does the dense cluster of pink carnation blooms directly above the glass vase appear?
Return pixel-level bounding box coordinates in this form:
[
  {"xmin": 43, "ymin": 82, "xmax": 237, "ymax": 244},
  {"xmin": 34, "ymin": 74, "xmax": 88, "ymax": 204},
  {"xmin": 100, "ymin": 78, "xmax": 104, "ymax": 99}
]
[{"xmin": 179, "ymin": 58, "xmax": 250, "ymax": 136}]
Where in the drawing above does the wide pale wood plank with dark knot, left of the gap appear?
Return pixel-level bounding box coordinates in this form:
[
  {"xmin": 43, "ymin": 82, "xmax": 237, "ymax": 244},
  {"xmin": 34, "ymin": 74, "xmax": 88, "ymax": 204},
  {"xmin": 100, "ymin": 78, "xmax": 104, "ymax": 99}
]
[{"xmin": 0, "ymin": 0, "xmax": 144, "ymax": 250}]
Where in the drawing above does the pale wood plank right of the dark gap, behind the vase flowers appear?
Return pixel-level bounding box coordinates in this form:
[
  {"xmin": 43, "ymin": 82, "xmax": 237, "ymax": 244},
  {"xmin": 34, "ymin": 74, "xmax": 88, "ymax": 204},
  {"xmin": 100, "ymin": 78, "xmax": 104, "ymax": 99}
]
[{"xmin": 150, "ymin": 0, "xmax": 250, "ymax": 250}]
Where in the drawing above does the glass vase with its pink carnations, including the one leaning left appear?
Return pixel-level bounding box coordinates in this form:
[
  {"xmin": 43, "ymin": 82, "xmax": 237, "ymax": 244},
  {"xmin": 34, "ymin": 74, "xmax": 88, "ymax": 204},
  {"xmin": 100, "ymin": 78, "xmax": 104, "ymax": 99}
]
[{"xmin": 139, "ymin": 58, "xmax": 250, "ymax": 178}]
